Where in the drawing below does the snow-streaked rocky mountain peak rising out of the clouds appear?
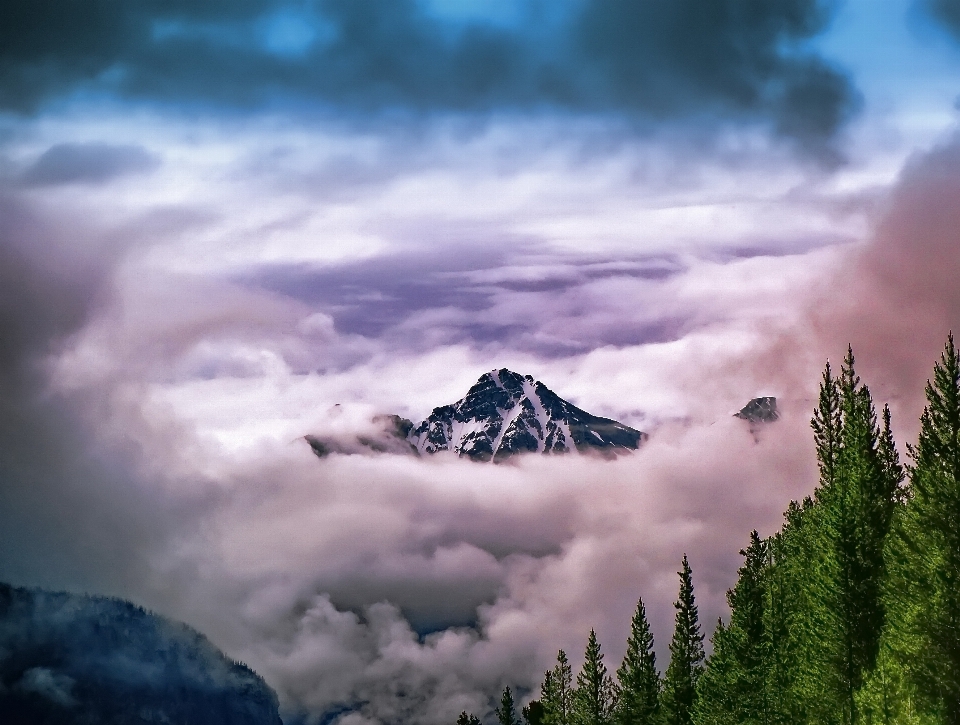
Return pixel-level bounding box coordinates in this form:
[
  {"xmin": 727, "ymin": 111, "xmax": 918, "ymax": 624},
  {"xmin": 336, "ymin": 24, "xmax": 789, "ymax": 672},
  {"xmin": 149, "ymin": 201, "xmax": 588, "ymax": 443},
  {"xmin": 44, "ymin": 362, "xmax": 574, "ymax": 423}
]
[{"xmin": 407, "ymin": 368, "xmax": 646, "ymax": 461}]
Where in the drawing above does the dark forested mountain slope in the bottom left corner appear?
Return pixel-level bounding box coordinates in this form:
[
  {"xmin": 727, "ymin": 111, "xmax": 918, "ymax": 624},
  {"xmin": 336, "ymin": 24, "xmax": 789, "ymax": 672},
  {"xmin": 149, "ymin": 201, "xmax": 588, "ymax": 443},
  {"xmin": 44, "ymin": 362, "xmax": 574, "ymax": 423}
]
[{"xmin": 0, "ymin": 583, "xmax": 281, "ymax": 725}]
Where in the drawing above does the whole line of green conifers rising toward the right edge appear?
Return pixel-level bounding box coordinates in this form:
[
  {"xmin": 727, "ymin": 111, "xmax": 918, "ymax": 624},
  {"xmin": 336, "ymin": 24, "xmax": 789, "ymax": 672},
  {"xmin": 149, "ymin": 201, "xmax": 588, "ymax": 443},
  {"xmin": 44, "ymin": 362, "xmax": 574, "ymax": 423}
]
[{"xmin": 457, "ymin": 334, "xmax": 960, "ymax": 725}]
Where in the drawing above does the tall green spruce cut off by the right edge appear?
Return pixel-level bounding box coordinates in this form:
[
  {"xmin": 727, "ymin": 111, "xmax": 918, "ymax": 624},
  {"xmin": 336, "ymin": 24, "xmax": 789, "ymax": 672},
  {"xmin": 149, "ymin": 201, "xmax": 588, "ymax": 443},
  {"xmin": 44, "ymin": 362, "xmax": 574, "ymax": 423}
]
[{"xmin": 891, "ymin": 333, "xmax": 960, "ymax": 725}]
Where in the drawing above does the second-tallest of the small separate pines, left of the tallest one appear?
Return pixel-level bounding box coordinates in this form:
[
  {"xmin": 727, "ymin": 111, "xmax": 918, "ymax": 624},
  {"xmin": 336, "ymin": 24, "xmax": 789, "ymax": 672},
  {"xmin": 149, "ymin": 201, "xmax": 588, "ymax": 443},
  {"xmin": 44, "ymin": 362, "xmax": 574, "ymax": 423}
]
[{"xmin": 614, "ymin": 599, "xmax": 660, "ymax": 725}]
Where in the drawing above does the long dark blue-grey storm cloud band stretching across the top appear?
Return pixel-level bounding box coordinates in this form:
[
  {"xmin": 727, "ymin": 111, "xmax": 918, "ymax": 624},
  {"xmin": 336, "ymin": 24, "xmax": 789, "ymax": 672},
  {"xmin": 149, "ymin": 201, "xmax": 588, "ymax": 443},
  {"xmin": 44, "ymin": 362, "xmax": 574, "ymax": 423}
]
[{"xmin": 0, "ymin": 0, "xmax": 857, "ymax": 148}]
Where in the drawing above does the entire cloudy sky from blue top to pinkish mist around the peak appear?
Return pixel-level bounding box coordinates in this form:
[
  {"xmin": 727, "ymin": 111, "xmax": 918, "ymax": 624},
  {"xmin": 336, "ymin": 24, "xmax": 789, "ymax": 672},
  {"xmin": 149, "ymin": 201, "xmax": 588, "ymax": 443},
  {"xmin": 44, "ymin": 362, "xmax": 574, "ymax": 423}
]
[{"xmin": 0, "ymin": 0, "xmax": 960, "ymax": 725}]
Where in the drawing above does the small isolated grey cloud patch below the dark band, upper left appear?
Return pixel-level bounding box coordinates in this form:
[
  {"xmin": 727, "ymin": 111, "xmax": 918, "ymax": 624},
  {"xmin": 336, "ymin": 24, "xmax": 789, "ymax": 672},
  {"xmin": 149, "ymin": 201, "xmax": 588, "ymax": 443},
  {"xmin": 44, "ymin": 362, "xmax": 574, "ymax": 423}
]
[{"xmin": 21, "ymin": 143, "xmax": 158, "ymax": 186}]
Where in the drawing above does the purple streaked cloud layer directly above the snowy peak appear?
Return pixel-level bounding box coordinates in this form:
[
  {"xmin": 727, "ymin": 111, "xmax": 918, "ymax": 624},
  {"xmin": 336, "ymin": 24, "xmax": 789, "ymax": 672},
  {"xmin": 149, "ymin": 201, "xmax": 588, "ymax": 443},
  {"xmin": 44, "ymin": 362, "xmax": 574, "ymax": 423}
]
[{"xmin": 240, "ymin": 253, "xmax": 684, "ymax": 356}]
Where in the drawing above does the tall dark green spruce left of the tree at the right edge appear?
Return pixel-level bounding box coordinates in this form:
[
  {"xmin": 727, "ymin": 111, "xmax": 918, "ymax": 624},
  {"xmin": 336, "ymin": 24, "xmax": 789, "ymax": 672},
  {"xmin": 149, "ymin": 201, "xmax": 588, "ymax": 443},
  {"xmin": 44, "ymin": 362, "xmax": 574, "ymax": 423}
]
[{"xmin": 810, "ymin": 347, "xmax": 902, "ymax": 724}]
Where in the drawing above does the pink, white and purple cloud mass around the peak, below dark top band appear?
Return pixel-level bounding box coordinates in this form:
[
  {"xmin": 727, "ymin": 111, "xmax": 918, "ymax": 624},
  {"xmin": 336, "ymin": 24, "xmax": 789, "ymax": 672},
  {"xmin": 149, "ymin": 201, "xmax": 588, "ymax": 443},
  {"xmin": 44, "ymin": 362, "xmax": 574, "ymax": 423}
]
[{"xmin": 0, "ymin": 58, "xmax": 960, "ymax": 725}]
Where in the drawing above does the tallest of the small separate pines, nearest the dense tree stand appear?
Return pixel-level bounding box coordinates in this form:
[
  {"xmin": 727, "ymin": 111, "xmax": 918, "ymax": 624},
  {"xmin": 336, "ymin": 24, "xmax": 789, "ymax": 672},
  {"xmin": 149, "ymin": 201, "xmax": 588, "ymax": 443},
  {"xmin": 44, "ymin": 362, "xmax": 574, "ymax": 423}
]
[{"xmin": 661, "ymin": 554, "xmax": 704, "ymax": 725}]
